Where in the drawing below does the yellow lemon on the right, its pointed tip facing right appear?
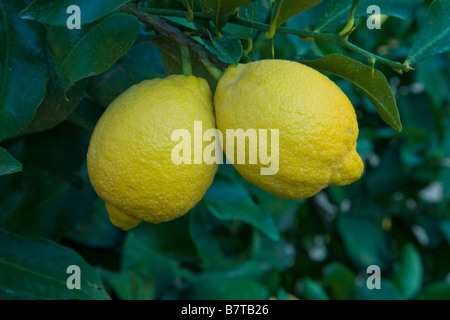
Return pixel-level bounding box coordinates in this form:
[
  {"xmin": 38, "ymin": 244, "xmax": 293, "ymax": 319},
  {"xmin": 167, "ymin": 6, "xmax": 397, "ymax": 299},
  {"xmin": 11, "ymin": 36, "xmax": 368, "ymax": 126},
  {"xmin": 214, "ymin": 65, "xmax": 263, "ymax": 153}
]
[{"xmin": 214, "ymin": 59, "xmax": 364, "ymax": 199}]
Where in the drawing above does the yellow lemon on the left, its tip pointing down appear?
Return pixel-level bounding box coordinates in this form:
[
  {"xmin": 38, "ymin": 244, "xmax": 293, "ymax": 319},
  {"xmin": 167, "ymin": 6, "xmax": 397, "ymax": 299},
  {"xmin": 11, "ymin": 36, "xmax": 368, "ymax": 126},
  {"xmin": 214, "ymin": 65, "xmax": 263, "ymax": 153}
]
[{"xmin": 87, "ymin": 75, "xmax": 217, "ymax": 230}]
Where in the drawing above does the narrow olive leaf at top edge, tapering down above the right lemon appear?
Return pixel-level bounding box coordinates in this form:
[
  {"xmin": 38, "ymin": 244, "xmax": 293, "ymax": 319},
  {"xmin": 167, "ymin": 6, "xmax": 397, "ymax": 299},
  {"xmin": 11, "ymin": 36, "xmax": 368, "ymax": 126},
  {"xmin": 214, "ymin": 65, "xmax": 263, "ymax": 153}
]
[{"xmin": 267, "ymin": 0, "xmax": 322, "ymax": 39}]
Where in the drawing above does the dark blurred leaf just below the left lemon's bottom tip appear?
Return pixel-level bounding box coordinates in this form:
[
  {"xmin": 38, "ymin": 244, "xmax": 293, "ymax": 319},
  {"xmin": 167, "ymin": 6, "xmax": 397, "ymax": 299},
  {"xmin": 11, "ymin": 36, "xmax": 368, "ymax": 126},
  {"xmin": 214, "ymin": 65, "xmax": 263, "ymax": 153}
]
[{"xmin": 67, "ymin": 198, "xmax": 123, "ymax": 248}]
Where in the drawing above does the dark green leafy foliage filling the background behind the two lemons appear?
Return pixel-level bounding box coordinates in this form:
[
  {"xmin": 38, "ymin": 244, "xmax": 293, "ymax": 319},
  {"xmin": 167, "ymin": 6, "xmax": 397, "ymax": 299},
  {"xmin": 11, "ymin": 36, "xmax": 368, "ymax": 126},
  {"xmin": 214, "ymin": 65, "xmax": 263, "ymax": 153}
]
[{"xmin": 0, "ymin": 0, "xmax": 450, "ymax": 299}]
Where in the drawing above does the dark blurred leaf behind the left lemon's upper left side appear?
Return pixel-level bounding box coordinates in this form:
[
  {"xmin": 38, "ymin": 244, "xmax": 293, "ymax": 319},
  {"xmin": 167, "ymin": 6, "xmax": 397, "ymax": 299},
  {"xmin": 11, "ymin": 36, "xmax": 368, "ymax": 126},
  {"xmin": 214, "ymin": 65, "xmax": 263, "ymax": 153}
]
[{"xmin": 88, "ymin": 42, "xmax": 164, "ymax": 107}]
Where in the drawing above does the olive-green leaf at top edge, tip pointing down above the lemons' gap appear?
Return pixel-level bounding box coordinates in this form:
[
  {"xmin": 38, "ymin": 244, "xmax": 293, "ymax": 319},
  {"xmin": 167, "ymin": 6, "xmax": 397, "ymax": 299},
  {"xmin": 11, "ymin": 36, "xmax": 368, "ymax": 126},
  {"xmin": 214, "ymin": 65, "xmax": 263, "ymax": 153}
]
[{"xmin": 200, "ymin": 0, "xmax": 250, "ymax": 35}]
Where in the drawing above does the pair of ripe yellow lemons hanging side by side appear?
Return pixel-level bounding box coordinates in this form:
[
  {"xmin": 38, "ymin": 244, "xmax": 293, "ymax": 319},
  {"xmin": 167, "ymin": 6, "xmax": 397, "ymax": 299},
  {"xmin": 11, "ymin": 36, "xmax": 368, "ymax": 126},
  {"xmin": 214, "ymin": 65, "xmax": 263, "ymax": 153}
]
[{"xmin": 87, "ymin": 60, "xmax": 363, "ymax": 230}]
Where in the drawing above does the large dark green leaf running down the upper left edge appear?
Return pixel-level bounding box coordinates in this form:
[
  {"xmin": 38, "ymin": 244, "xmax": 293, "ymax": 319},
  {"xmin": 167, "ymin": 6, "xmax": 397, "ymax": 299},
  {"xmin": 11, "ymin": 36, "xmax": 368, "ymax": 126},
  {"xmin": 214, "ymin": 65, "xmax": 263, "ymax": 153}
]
[{"xmin": 0, "ymin": 0, "xmax": 48, "ymax": 141}]
